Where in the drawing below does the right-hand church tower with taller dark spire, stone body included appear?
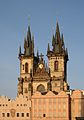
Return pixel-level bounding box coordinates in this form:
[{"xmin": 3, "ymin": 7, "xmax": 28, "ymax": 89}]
[{"xmin": 47, "ymin": 22, "xmax": 69, "ymax": 92}]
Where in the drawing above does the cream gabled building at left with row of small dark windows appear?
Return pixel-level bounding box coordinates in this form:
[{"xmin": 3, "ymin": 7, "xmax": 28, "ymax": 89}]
[{"xmin": 0, "ymin": 95, "xmax": 31, "ymax": 120}]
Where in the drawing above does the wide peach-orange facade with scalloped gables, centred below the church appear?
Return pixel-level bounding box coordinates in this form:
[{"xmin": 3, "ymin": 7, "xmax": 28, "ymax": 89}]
[{"xmin": 32, "ymin": 92, "xmax": 69, "ymax": 120}]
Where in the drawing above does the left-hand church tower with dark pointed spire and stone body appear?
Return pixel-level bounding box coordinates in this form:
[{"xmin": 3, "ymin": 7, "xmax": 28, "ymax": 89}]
[{"xmin": 18, "ymin": 26, "xmax": 35, "ymax": 96}]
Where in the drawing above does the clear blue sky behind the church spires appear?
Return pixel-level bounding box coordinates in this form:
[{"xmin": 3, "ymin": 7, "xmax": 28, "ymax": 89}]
[{"xmin": 0, "ymin": 0, "xmax": 84, "ymax": 98}]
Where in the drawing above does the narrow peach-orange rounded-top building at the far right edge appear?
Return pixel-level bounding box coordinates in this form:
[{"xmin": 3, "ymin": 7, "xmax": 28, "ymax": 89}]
[{"xmin": 71, "ymin": 90, "xmax": 84, "ymax": 120}]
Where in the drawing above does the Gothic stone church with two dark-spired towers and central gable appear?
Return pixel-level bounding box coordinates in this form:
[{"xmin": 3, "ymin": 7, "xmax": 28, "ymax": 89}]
[{"xmin": 18, "ymin": 22, "xmax": 69, "ymax": 99}]
